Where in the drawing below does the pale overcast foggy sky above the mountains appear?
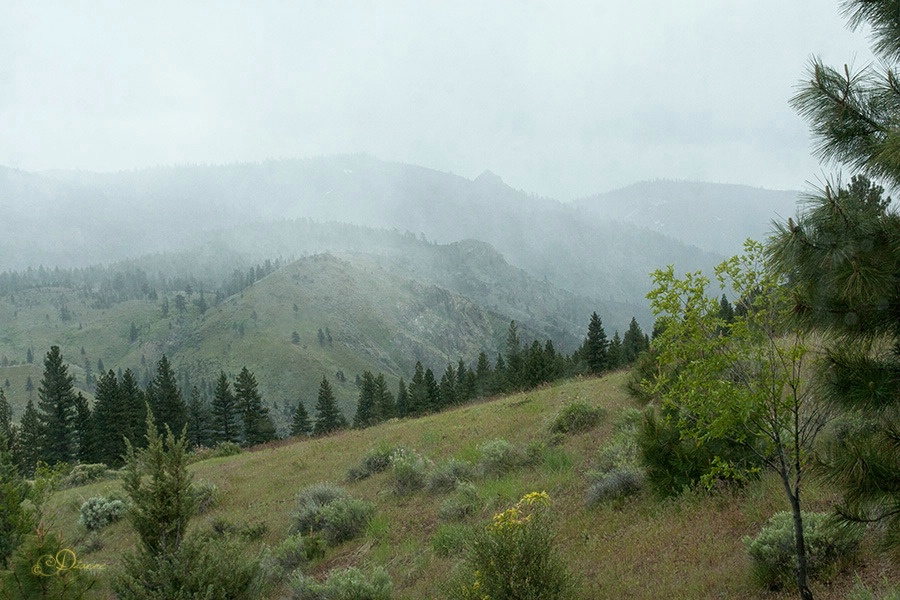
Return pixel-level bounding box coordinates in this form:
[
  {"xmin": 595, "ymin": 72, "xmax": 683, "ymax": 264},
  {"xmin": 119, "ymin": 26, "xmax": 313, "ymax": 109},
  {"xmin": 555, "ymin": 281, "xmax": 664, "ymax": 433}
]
[{"xmin": 0, "ymin": 0, "xmax": 871, "ymax": 200}]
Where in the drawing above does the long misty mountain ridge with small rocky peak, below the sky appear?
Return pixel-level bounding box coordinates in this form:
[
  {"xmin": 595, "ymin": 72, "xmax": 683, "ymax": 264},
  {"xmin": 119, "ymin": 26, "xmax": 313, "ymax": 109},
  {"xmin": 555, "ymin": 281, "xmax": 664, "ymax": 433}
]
[{"xmin": 0, "ymin": 156, "xmax": 716, "ymax": 303}]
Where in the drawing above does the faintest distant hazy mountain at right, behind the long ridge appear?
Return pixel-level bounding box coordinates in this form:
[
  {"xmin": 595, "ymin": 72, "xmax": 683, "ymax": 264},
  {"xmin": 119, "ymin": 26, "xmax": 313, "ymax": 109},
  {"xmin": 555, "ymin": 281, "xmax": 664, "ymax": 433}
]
[{"xmin": 574, "ymin": 181, "xmax": 799, "ymax": 256}]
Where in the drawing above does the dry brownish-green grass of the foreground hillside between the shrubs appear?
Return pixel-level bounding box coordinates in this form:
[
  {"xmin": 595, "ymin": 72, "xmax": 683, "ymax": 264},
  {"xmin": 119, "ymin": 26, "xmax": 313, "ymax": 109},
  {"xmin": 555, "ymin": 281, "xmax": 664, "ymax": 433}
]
[{"xmin": 44, "ymin": 373, "xmax": 900, "ymax": 600}]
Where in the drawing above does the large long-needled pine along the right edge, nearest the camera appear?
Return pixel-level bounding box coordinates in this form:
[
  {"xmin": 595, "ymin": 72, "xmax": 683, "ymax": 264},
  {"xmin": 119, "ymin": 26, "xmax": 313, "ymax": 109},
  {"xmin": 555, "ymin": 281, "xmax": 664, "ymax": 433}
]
[{"xmin": 770, "ymin": 0, "xmax": 900, "ymax": 548}]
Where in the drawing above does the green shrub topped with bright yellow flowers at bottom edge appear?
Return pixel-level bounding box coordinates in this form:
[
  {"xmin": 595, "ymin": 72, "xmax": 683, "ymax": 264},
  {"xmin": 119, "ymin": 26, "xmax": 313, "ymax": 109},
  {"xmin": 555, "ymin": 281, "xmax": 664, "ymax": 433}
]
[{"xmin": 450, "ymin": 492, "xmax": 574, "ymax": 600}]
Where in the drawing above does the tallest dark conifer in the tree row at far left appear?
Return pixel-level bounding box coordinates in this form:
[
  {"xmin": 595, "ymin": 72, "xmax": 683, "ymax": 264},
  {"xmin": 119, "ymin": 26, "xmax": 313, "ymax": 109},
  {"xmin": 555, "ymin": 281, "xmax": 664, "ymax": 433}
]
[{"xmin": 38, "ymin": 346, "xmax": 77, "ymax": 465}]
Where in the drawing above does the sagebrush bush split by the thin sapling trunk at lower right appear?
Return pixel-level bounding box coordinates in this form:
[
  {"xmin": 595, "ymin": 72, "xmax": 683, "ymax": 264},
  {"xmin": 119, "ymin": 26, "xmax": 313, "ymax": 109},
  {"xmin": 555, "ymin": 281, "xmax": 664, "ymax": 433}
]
[{"xmin": 744, "ymin": 512, "xmax": 863, "ymax": 589}]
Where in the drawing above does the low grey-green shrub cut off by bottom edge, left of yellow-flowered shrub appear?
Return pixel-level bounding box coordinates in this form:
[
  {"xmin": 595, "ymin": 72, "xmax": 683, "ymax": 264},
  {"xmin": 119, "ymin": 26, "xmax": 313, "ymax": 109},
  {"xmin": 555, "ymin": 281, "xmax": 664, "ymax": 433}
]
[{"xmin": 290, "ymin": 567, "xmax": 393, "ymax": 600}]
